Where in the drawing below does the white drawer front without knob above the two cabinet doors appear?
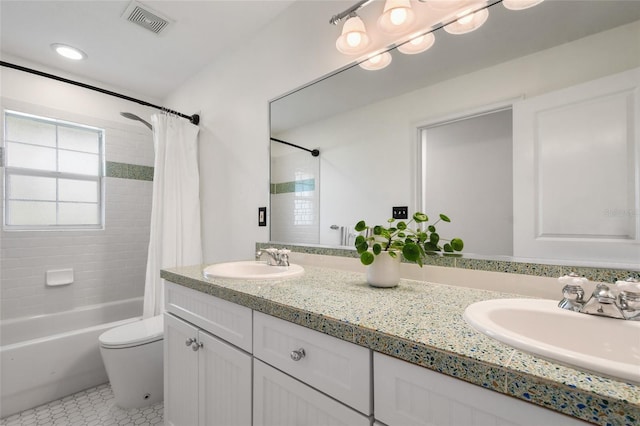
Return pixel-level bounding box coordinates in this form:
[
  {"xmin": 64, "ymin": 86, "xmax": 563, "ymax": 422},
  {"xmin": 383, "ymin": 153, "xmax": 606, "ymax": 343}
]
[{"xmin": 164, "ymin": 281, "xmax": 252, "ymax": 352}]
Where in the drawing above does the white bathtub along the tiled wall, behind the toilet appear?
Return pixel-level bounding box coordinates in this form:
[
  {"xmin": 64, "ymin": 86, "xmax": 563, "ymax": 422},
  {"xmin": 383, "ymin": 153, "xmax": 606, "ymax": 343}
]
[{"xmin": 0, "ymin": 297, "xmax": 142, "ymax": 418}]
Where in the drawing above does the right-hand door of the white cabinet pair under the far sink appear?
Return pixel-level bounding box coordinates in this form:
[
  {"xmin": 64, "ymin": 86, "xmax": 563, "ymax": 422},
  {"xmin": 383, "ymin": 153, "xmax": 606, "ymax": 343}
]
[{"xmin": 198, "ymin": 331, "xmax": 251, "ymax": 426}]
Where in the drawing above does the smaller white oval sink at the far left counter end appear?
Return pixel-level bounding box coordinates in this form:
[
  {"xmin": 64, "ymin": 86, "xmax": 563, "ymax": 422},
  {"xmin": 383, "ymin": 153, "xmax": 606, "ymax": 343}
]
[{"xmin": 202, "ymin": 260, "xmax": 304, "ymax": 280}]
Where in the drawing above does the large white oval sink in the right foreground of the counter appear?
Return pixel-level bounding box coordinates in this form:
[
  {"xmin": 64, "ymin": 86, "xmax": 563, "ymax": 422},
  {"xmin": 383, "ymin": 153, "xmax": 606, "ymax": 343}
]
[{"xmin": 464, "ymin": 299, "xmax": 640, "ymax": 384}]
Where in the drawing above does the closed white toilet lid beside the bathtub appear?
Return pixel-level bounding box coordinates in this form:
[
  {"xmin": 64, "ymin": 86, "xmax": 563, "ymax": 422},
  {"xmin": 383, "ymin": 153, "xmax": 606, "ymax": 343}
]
[{"xmin": 98, "ymin": 315, "xmax": 164, "ymax": 348}]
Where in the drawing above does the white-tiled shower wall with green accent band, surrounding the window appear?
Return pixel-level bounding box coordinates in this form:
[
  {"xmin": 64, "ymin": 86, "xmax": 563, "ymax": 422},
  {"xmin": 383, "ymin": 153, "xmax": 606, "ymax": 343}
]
[{"xmin": 0, "ymin": 99, "xmax": 154, "ymax": 319}]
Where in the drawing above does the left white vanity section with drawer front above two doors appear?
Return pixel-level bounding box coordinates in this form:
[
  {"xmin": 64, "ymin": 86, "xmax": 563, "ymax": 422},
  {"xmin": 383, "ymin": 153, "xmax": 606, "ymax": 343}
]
[{"xmin": 164, "ymin": 283, "xmax": 252, "ymax": 426}]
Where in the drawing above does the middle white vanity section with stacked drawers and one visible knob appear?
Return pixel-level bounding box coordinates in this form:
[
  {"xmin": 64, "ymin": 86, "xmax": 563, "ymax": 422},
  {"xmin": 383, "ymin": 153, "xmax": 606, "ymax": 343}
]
[{"xmin": 253, "ymin": 312, "xmax": 372, "ymax": 426}]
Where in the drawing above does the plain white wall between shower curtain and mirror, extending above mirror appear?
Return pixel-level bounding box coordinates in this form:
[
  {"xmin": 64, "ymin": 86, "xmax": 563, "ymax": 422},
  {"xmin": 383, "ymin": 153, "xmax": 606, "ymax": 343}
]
[{"xmin": 161, "ymin": 1, "xmax": 356, "ymax": 263}]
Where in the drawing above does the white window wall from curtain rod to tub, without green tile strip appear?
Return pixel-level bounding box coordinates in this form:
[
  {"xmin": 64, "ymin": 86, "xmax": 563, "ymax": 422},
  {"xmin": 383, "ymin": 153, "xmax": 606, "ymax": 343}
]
[{"xmin": 0, "ymin": 65, "xmax": 154, "ymax": 319}]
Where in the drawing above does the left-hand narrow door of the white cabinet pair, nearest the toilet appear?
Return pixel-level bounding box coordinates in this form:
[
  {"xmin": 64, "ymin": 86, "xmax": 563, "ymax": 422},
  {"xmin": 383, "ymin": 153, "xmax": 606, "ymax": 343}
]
[{"xmin": 164, "ymin": 314, "xmax": 198, "ymax": 426}]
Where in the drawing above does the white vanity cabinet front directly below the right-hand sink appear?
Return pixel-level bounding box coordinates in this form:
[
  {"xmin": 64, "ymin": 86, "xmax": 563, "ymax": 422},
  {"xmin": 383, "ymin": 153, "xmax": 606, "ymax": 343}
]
[{"xmin": 373, "ymin": 353, "xmax": 587, "ymax": 426}]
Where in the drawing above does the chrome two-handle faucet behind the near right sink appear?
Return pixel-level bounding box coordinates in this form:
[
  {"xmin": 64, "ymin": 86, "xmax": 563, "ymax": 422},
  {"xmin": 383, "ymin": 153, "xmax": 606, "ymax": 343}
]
[{"xmin": 558, "ymin": 273, "xmax": 640, "ymax": 321}]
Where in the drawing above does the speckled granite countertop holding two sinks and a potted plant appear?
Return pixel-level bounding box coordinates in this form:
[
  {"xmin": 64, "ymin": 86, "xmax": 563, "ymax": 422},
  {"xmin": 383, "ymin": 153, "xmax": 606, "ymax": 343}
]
[{"xmin": 161, "ymin": 265, "xmax": 640, "ymax": 425}]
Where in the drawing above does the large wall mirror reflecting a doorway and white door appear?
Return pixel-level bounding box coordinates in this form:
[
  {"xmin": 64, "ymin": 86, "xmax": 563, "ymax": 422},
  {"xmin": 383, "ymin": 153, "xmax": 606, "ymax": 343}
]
[{"xmin": 270, "ymin": 0, "xmax": 640, "ymax": 269}]
